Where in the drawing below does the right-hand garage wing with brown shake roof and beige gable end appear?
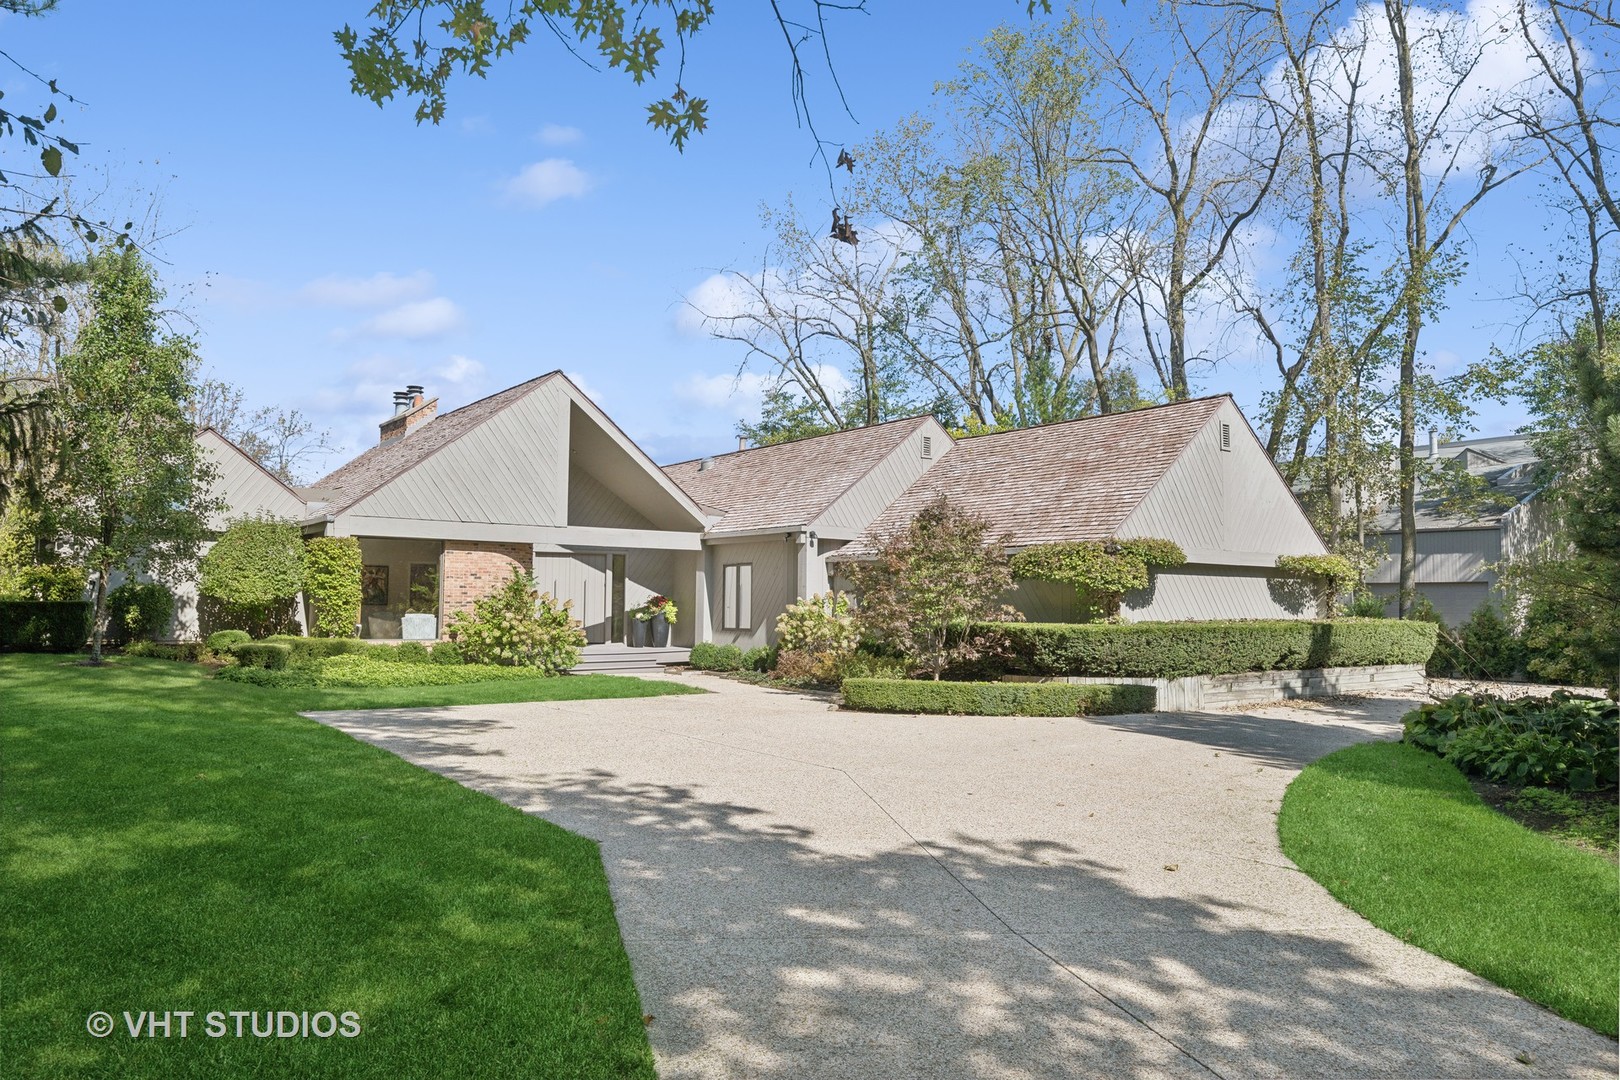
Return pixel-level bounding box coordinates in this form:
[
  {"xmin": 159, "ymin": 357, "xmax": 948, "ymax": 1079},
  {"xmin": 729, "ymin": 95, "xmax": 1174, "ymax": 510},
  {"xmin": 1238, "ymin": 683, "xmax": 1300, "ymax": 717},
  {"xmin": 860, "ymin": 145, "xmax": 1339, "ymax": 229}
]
[{"xmin": 836, "ymin": 395, "xmax": 1325, "ymax": 622}]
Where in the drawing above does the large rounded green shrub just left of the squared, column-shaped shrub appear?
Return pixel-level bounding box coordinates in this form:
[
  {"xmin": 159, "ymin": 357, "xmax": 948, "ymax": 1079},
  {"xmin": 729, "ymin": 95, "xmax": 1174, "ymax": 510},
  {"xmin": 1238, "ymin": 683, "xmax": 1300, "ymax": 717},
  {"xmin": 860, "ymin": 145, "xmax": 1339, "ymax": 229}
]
[{"xmin": 198, "ymin": 515, "xmax": 305, "ymax": 636}]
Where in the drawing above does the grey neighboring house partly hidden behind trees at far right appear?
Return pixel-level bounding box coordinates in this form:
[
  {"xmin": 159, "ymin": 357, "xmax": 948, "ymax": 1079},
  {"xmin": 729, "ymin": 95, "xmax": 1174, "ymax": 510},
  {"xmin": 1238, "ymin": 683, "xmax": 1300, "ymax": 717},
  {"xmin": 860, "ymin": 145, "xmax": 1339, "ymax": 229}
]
[{"xmin": 1367, "ymin": 436, "xmax": 1550, "ymax": 627}]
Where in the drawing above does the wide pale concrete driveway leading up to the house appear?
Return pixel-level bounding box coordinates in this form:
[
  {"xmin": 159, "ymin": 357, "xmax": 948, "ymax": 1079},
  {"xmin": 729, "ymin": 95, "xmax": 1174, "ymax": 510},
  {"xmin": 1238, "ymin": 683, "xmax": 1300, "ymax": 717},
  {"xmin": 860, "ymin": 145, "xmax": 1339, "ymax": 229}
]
[{"xmin": 309, "ymin": 675, "xmax": 1617, "ymax": 1080}]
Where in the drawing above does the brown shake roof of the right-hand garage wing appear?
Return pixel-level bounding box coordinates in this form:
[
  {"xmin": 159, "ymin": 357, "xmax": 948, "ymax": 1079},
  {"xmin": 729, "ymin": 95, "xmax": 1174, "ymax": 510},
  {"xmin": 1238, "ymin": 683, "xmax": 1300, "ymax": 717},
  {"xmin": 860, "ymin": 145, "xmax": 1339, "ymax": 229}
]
[{"xmin": 834, "ymin": 395, "xmax": 1228, "ymax": 559}]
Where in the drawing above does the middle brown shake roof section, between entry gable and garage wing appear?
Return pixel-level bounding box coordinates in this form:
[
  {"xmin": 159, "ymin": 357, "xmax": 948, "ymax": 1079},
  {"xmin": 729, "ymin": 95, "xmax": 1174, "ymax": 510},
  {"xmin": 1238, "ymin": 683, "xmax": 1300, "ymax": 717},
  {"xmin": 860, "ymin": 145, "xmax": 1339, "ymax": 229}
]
[{"xmin": 664, "ymin": 416, "xmax": 949, "ymax": 533}]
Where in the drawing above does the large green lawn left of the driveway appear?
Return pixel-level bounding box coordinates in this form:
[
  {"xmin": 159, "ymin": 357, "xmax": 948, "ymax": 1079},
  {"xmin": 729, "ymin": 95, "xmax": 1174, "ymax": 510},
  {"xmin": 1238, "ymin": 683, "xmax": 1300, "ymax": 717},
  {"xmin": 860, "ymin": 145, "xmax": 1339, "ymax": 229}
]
[{"xmin": 0, "ymin": 656, "xmax": 687, "ymax": 1080}]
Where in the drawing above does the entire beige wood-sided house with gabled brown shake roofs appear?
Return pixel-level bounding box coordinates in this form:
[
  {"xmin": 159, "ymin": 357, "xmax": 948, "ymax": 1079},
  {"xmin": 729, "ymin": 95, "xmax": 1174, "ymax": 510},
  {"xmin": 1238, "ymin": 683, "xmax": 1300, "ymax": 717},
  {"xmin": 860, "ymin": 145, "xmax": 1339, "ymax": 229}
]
[{"xmin": 186, "ymin": 372, "xmax": 1322, "ymax": 648}]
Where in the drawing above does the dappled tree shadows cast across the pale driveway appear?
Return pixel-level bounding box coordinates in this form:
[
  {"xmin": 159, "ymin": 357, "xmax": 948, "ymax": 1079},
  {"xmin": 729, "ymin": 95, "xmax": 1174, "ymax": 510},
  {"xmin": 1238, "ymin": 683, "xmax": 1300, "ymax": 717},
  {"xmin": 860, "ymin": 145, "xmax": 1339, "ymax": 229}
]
[{"xmin": 312, "ymin": 711, "xmax": 1615, "ymax": 1080}]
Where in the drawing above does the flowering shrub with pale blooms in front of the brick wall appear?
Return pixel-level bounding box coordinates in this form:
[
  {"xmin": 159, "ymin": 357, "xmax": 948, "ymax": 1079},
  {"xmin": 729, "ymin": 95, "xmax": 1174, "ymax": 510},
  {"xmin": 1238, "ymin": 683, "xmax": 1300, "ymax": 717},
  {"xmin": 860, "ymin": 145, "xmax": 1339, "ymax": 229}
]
[{"xmin": 449, "ymin": 570, "xmax": 585, "ymax": 675}]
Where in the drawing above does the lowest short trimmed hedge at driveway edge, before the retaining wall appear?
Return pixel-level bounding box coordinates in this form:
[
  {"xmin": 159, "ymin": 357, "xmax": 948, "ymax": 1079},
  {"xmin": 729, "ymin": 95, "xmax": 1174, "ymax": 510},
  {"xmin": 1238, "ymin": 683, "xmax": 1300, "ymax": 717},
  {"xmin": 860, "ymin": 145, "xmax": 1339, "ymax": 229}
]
[{"xmin": 844, "ymin": 678, "xmax": 1158, "ymax": 716}]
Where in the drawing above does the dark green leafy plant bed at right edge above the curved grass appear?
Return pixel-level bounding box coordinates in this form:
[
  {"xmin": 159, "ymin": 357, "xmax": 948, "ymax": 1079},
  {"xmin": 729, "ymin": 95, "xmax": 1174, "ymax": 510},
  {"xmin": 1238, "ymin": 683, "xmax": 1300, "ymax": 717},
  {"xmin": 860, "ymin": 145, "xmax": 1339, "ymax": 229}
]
[{"xmin": 1401, "ymin": 690, "xmax": 1620, "ymax": 792}]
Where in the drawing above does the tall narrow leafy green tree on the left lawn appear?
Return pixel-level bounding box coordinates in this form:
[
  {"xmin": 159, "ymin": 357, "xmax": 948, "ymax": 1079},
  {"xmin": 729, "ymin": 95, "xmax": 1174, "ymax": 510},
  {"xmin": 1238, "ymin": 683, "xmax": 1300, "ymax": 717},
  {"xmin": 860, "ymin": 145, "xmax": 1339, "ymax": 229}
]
[{"xmin": 47, "ymin": 251, "xmax": 220, "ymax": 662}]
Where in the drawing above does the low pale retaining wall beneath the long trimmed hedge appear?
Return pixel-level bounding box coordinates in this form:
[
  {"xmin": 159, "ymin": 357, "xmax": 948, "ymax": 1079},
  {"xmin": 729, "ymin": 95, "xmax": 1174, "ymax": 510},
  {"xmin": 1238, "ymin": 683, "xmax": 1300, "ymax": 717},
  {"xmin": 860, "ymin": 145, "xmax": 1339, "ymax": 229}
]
[{"xmin": 1004, "ymin": 664, "xmax": 1426, "ymax": 712}]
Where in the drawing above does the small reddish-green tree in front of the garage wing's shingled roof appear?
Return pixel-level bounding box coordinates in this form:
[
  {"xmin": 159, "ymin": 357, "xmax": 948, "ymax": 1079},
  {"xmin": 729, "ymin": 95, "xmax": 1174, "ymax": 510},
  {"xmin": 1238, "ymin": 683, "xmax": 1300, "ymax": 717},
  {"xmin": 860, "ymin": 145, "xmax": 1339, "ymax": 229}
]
[{"xmin": 849, "ymin": 497, "xmax": 1013, "ymax": 680}]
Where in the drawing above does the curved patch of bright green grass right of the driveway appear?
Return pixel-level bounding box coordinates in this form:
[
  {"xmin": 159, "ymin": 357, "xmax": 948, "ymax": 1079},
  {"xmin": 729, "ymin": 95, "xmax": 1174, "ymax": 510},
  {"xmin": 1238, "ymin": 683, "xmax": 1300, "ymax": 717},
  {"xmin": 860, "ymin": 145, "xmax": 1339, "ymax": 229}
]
[{"xmin": 1277, "ymin": 743, "xmax": 1620, "ymax": 1036}]
